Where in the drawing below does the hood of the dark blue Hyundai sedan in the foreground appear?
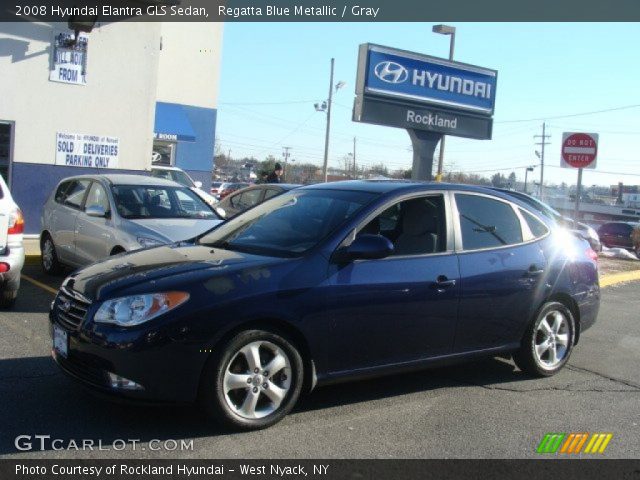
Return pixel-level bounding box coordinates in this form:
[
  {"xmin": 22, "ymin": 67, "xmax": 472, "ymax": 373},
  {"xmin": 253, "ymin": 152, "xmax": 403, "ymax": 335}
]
[{"xmin": 64, "ymin": 245, "xmax": 282, "ymax": 301}]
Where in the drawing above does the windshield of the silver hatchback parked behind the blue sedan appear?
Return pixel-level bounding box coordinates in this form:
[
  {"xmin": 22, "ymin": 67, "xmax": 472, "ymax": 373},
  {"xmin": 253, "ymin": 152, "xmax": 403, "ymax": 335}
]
[{"xmin": 111, "ymin": 185, "xmax": 217, "ymax": 219}]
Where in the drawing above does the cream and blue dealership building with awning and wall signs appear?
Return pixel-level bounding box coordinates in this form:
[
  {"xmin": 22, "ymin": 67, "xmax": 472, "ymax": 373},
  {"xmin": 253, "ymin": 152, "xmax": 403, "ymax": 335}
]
[{"xmin": 0, "ymin": 22, "xmax": 222, "ymax": 234}]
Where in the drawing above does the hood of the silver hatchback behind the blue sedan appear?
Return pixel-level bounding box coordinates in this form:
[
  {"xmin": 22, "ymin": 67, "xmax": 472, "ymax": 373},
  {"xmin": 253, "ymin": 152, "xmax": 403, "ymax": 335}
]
[{"xmin": 127, "ymin": 218, "xmax": 222, "ymax": 243}]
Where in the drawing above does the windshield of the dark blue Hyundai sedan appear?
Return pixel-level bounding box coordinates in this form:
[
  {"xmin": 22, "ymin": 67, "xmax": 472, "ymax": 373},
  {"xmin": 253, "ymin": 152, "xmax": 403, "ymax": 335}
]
[{"xmin": 199, "ymin": 189, "xmax": 377, "ymax": 257}]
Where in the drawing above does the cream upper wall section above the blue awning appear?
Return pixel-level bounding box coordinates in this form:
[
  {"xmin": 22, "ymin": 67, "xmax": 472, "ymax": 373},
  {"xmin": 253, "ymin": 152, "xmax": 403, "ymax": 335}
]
[{"xmin": 157, "ymin": 22, "xmax": 224, "ymax": 108}]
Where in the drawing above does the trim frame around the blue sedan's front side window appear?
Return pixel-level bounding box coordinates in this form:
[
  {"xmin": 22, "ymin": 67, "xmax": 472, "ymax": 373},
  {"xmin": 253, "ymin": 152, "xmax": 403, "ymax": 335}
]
[{"xmin": 332, "ymin": 190, "xmax": 455, "ymax": 262}]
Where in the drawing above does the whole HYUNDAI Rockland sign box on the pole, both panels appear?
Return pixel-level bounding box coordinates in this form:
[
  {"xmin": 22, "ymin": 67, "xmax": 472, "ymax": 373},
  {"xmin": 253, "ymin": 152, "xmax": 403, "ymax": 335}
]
[{"xmin": 353, "ymin": 43, "xmax": 498, "ymax": 139}]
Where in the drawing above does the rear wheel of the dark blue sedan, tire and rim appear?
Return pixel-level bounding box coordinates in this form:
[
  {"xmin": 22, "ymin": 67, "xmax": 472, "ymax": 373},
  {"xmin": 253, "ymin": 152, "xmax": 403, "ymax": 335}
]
[{"xmin": 513, "ymin": 302, "xmax": 575, "ymax": 377}]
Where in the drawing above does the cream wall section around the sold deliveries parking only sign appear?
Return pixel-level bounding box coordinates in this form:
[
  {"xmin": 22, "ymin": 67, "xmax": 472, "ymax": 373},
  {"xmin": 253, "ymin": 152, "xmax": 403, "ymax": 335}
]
[{"xmin": 0, "ymin": 22, "xmax": 161, "ymax": 173}]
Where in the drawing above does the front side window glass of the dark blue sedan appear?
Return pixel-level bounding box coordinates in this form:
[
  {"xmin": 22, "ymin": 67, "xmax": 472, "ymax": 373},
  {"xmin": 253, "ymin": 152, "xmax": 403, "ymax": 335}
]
[{"xmin": 357, "ymin": 195, "xmax": 447, "ymax": 256}]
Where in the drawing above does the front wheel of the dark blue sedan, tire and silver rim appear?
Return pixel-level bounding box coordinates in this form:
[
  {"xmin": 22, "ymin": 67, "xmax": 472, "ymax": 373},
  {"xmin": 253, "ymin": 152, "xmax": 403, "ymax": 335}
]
[{"xmin": 200, "ymin": 330, "xmax": 304, "ymax": 430}]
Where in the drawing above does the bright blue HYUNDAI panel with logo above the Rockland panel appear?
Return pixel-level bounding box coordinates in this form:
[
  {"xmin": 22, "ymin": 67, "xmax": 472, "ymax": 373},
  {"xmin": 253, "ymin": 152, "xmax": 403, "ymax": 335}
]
[{"xmin": 364, "ymin": 45, "xmax": 497, "ymax": 115}]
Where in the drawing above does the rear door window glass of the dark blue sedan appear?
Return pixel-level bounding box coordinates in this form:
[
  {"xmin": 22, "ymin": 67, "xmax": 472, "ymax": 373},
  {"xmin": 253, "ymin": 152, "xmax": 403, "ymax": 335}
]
[{"xmin": 456, "ymin": 193, "xmax": 522, "ymax": 250}]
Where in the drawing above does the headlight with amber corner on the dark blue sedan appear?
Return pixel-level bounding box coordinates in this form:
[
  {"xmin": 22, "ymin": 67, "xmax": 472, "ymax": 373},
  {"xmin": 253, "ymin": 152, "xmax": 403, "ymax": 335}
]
[{"xmin": 93, "ymin": 292, "xmax": 189, "ymax": 327}]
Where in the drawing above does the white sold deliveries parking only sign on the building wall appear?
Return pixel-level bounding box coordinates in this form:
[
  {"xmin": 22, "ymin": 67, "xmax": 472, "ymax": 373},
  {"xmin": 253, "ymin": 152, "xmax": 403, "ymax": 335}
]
[{"xmin": 56, "ymin": 132, "xmax": 120, "ymax": 168}]
